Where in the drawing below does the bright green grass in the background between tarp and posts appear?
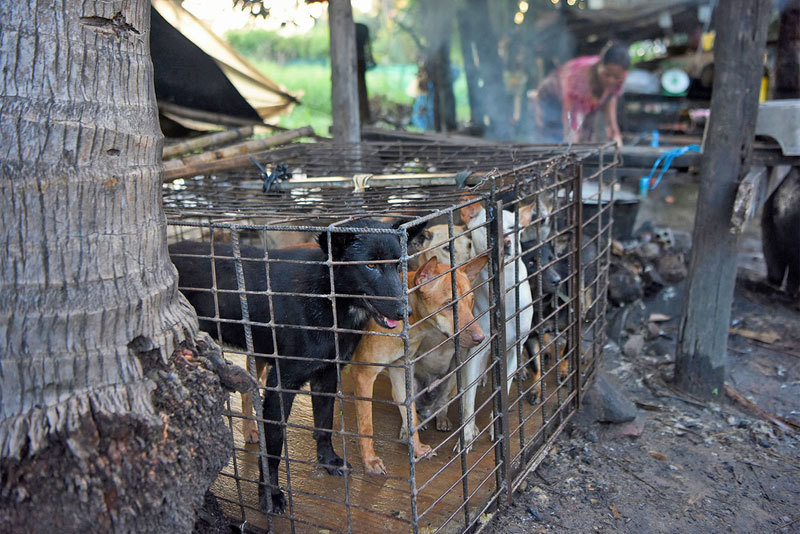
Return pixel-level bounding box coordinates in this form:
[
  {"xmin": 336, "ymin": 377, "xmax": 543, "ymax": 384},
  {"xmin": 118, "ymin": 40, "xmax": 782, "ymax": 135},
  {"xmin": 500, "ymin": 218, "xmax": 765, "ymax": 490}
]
[{"xmin": 250, "ymin": 58, "xmax": 469, "ymax": 136}]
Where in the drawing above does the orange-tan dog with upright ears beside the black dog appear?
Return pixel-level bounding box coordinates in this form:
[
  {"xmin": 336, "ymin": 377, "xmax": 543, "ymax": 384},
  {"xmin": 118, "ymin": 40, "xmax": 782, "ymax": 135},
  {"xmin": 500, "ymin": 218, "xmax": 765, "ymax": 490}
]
[{"xmin": 350, "ymin": 255, "xmax": 488, "ymax": 474}]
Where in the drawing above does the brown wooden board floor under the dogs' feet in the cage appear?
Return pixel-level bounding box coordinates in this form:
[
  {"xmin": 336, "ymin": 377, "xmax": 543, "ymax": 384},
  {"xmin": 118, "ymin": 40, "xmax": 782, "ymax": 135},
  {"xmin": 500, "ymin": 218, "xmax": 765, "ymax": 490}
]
[{"xmin": 212, "ymin": 353, "xmax": 592, "ymax": 532}]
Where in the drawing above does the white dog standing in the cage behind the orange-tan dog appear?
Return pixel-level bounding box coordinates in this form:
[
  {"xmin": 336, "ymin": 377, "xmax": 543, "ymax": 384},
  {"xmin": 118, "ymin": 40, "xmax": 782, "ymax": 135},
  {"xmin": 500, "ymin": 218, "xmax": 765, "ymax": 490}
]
[{"xmin": 456, "ymin": 203, "xmax": 533, "ymax": 449}]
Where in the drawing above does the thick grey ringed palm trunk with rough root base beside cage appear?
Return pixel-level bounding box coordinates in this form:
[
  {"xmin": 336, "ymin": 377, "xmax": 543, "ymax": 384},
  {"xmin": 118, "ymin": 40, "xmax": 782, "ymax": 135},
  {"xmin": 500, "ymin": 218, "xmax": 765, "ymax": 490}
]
[{"xmin": 0, "ymin": 0, "xmax": 230, "ymax": 532}]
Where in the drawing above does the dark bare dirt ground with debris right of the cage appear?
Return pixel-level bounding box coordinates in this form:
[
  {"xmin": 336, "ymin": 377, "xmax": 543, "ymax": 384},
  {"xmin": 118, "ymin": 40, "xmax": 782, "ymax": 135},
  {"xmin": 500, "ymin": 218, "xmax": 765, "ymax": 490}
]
[{"xmin": 486, "ymin": 177, "xmax": 800, "ymax": 534}]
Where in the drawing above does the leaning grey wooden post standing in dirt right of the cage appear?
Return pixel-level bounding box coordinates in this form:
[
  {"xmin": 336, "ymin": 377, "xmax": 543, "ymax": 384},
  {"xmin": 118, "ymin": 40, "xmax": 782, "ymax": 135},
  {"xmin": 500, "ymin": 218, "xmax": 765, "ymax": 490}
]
[{"xmin": 675, "ymin": 0, "xmax": 772, "ymax": 398}]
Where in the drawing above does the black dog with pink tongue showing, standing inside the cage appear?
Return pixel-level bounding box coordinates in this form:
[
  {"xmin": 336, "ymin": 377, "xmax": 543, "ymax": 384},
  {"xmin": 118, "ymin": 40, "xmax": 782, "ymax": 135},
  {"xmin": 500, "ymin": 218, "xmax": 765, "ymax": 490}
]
[{"xmin": 170, "ymin": 219, "xmax": 424, "ymax": 513}]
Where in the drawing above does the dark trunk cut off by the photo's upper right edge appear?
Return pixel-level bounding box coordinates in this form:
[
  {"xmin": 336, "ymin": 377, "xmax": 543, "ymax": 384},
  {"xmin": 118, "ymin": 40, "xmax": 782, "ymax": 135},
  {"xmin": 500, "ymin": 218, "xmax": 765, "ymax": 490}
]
[{"xmin": 773, "ymin": 0, "xmax": 800, "ymax": 99}]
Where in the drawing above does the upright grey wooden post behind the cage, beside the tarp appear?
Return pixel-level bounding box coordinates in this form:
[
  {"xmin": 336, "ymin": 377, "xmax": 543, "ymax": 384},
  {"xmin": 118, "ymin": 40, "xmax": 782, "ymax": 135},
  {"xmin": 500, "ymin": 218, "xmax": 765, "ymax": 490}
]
[{"xmin": 328, "ymin": 0, "xmax": 361, "ymax": 143}]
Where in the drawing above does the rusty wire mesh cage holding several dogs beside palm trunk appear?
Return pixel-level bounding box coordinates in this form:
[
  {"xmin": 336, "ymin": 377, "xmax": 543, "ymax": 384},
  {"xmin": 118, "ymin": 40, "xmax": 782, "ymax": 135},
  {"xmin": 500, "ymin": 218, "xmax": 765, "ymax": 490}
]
[{"xmin": 164, "ymin": 143, "xmax": 617, "ymax": 532}]
